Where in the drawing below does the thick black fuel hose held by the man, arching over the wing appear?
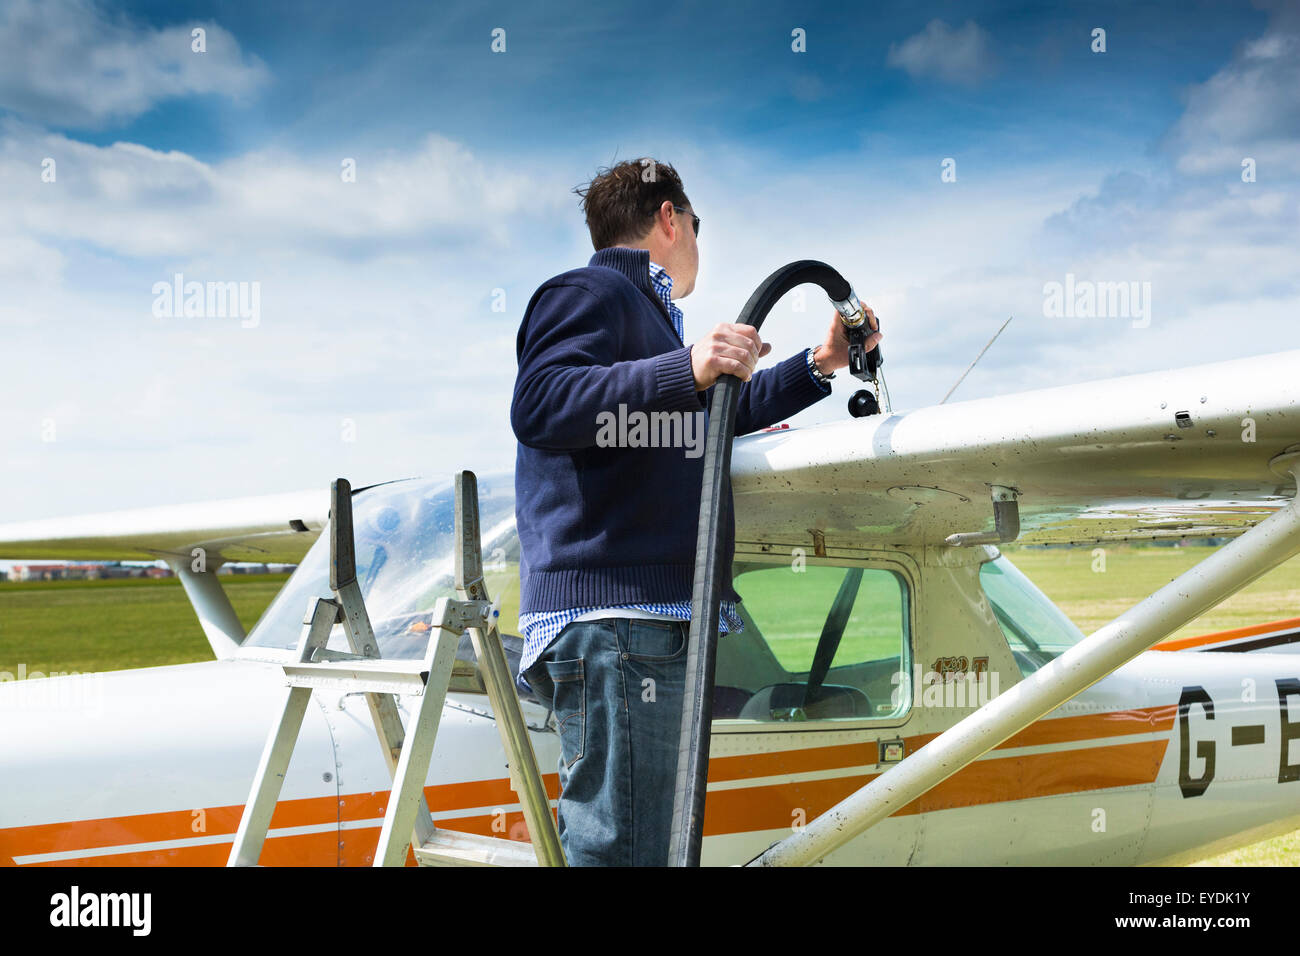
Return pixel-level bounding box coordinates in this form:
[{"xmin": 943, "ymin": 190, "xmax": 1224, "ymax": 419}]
[{"xmin": 668, "ymin": 259, "xmax": 857, "ymax": 866}]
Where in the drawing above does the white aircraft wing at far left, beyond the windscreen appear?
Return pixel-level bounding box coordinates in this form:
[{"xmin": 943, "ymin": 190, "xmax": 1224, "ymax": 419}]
[{"xmin": 0, "ymin": 488, "xmax": 329, "ymax": 563}]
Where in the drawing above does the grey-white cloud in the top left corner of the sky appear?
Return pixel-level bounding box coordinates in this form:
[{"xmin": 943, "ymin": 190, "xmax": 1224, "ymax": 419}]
[{"xmin": 0, "ymin": 0, "xmax": 270, "ymax": 127}]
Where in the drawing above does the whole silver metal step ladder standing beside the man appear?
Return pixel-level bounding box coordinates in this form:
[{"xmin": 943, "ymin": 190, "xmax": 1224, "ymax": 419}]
[{"xmin": 226, "ymin": 471, "xmax": 564, "ymax": 866}]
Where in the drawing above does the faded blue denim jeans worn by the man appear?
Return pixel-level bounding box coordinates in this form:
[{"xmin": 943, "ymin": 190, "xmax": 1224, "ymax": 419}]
[{"xmin": 525, "ymin": 618, "xmax": 690, "ymax": 866}]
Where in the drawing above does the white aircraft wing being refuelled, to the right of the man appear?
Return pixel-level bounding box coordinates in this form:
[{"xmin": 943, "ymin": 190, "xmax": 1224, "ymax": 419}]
[{"xmin": 732, "ymin": 350, "xmax": 1300, "ymax": 553}]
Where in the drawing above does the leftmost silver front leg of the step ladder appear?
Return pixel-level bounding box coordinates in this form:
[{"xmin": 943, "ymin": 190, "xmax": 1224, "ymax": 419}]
[{"xmin": 226, "ymin": 597, "xmax": 338, "ymax": 866}]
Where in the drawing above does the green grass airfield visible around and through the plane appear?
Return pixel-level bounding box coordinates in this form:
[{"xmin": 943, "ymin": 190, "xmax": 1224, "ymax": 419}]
[{"xmin": 0, "ymin": 545, "xmax": 1300, "ymax": 866}]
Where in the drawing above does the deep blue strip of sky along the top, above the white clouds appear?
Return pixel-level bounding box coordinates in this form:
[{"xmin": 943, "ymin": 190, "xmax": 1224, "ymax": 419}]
[{"xmin": 63, "ymin": 3, "xmax": 1268, "ymax": 161}]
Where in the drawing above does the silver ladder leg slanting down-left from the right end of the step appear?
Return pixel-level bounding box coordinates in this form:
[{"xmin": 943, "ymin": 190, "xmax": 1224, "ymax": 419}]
[{"xmin": 374, "ymin": 628, "xmax": 459, "ymax": 866}]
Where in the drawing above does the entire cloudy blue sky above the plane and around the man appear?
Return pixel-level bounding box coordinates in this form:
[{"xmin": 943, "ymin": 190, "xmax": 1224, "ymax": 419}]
[{"xmin": 0, "ymin": 0, "xmax": 1300, "ymax": 522}]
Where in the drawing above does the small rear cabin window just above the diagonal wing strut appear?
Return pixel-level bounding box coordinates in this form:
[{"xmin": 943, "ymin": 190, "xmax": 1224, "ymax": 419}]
[{"xmin": 979, "ymin": 555, "xmax": 1084, "ymax": 676}]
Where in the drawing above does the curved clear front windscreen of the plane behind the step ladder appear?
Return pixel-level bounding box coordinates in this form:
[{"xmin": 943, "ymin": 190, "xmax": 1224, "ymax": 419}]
[{"xmin": 242, "ymin": 472, "xmax": 519, "ymax": 658}]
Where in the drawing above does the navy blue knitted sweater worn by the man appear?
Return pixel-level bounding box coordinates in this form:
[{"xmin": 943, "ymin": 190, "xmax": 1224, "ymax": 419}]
[{"xmin": 510, "ymin": 246, "xmax": 831, "ymax": 613}]
